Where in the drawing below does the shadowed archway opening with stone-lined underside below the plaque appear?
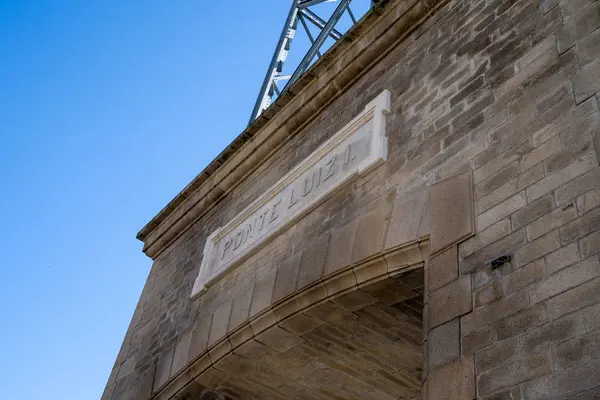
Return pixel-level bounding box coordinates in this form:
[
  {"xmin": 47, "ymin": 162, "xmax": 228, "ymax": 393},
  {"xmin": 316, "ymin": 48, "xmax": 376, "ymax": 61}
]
[{"xmin": 190, "ymin": 267, "xmax": 424, "ymax": 400}]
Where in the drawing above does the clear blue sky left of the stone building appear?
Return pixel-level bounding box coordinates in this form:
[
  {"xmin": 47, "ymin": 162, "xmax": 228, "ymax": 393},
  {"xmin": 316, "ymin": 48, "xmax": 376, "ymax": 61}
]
[{"xmin": 0, "ymin": 0, "xmax": 370, "ymax": 400}]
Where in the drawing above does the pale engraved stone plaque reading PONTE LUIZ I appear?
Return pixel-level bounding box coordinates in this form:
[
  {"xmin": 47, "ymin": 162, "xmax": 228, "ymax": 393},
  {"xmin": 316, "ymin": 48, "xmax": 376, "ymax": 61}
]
[{"xmin": 192, "ymin": 90, "xmax": 390, "ymax": 296}]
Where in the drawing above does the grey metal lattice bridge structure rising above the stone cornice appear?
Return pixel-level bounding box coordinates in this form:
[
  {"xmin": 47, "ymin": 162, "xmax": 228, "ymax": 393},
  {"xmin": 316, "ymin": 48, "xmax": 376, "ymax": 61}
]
[{"xmin": 249, "ymin": 0, "xmax": 377, "ymax": 123}]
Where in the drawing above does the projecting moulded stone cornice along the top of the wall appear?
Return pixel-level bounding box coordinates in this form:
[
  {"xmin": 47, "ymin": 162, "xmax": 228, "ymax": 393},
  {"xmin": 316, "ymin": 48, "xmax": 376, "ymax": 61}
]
[{"xmin": 137, "ymin": 0, "xmax": 447, "ymax": 259}]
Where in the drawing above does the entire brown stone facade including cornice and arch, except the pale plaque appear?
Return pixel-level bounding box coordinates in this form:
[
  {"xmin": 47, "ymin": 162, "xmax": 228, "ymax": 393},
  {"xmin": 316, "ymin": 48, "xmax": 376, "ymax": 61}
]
[{"xmin": 102, "ymin": 0, "xmax": 600, "ymax": 400}]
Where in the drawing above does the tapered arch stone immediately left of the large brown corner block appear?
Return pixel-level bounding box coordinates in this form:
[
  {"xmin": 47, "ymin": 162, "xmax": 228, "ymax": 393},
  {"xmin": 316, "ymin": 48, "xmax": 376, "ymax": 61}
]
[{"xmin": 385, "ymin": 190, "xmax": 427, "ymax": 249}]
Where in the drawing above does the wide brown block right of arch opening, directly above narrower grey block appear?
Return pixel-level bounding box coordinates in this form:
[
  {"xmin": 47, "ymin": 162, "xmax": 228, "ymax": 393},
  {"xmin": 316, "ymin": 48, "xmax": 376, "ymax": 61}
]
[{"xmin": 428, "ymin": 276, "xmax": 473, "ymax": 329}]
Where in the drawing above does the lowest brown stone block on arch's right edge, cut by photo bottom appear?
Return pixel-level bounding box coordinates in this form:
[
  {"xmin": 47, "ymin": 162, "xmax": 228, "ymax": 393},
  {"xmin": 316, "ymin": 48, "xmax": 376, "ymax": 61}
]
[{"xmin": 427, "ymin": 357, "xmax": 476, "ymax": 400}]
